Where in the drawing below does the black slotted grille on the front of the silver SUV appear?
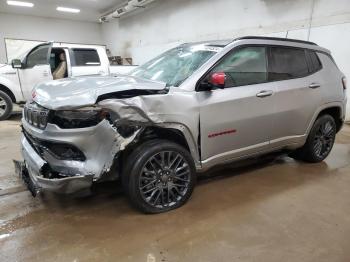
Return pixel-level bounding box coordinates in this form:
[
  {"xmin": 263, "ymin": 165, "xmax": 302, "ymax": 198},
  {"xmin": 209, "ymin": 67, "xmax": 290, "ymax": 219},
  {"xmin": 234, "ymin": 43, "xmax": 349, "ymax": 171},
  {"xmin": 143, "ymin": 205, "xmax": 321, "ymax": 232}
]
[{"xmin": 23, "ymin": 102, "xmax": 49, "ymax": 129}]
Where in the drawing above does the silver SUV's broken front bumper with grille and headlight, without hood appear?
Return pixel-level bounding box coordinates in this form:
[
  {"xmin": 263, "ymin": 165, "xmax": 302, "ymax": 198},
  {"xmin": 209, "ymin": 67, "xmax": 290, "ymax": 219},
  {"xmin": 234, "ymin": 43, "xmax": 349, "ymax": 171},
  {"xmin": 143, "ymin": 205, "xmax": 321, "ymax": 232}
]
[{"xmin": 15, "ymin": 102, "xmax": 141, "ymax": 196}]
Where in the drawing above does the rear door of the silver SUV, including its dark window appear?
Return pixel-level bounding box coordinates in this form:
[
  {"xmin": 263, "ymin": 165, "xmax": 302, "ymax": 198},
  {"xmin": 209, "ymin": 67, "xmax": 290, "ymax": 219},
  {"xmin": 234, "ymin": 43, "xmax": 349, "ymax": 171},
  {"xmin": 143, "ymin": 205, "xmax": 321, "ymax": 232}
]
[{"xmin": 269, "ymin": 46, "xmax": 323, "ymax": 146}]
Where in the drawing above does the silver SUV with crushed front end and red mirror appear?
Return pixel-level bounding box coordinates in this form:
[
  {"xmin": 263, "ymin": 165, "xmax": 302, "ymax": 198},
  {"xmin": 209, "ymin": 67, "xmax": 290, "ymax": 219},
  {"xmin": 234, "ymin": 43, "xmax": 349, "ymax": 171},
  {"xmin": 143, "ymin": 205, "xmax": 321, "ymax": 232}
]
[{"xmin": 16, "ymin": 37, "xmax": 346, "ymax": 213}]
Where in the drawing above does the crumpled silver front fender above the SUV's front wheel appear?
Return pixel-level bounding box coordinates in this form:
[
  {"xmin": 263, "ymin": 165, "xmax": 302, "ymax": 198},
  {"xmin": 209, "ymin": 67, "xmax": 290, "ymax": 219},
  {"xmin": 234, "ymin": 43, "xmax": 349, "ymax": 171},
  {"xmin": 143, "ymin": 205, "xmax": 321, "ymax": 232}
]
[{"xmin": 98, "ymin": 95, "xmax": 201, "ymax": 169}]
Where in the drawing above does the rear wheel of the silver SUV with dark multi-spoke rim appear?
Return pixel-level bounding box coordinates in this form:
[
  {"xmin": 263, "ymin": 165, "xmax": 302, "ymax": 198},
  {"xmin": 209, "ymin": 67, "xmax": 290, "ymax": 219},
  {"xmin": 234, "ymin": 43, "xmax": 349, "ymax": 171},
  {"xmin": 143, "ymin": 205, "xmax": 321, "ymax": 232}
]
[{"xmin": 290, "ymin": 115, "xmax": 337, "ymax": 163}]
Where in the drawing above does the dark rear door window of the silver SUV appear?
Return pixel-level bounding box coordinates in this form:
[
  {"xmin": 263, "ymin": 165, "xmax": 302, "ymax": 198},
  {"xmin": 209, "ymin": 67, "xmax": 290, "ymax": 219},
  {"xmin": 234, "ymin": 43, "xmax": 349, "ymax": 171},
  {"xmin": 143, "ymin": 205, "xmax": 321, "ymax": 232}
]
[{"xmin": 269, "ymin": 47, "xmax": 309, "ymax": 81}]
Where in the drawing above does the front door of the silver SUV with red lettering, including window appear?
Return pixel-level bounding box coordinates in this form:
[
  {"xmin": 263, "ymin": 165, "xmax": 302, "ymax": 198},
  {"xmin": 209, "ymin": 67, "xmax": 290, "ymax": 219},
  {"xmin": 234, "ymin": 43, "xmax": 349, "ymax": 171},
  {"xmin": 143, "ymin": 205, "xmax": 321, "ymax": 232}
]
[{"xmin": 198, "ymin": 46, "xmax": 275, "ymax": 166}]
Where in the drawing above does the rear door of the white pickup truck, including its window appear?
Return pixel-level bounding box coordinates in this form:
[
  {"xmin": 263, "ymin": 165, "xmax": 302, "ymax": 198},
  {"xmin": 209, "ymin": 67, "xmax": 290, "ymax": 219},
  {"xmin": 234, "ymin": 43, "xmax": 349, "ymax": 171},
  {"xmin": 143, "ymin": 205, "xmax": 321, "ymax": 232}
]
[{"xmin": 70, "ymin": 48, "xmax": 108, "ymax": 76}]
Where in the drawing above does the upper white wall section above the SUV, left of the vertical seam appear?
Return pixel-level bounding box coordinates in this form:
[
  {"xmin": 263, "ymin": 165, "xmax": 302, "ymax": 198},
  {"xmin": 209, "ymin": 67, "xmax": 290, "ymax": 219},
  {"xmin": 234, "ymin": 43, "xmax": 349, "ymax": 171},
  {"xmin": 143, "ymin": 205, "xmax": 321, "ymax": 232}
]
[{"xmin": 102, "ymin": 0, "xmax": 312, "ymax": 63}]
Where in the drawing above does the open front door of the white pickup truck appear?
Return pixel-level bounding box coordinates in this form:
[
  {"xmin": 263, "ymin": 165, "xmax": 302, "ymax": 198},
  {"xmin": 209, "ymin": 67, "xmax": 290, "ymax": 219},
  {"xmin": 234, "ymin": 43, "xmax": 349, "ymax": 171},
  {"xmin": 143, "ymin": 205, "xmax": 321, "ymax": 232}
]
[{"xmin": 18, "ymin": 44, "xmax": 52, "ymax": 100}]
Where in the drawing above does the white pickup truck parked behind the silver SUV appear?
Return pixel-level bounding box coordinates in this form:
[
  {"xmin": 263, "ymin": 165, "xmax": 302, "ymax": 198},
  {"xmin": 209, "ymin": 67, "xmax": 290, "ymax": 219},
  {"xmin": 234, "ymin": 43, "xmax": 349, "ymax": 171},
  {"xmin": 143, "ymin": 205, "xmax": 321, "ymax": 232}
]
[{"xmin": 0, "ymin": 42, "xmax": 135, "ymax": 120}]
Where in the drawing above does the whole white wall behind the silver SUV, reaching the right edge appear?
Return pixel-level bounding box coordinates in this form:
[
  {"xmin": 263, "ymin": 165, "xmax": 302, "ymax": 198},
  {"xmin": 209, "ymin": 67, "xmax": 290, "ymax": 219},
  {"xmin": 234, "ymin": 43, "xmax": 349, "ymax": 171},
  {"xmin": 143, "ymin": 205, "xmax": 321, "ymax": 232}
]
[{"xmin": 102, "ymin": 0, "xmax": 350, "ymax": 120}]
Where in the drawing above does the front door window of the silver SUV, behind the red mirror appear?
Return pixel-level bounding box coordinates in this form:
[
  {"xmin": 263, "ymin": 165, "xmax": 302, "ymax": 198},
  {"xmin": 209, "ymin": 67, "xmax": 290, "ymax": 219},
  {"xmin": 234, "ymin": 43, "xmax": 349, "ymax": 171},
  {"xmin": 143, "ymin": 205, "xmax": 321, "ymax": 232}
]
[{"xmin": 212, "ymin": 46, "xmax": 267, "ymax": 87}]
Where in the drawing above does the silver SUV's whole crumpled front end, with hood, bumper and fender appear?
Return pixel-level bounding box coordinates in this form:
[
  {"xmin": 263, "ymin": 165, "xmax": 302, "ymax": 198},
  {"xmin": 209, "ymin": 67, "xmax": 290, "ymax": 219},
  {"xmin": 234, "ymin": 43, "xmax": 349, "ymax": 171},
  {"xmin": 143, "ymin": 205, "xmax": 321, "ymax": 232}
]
[{"xmin": 16, "ymin": 76, "xmax": 199, "ymax": 195}]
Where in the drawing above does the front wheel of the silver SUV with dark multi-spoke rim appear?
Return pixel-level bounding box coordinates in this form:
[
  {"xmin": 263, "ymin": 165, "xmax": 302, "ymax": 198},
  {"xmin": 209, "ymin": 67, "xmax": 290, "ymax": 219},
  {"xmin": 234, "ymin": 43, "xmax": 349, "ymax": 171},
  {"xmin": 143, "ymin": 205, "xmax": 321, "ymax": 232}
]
[{"xmin": 122, "ymin": 139, "xmax": 196, "ymax": 214}]
